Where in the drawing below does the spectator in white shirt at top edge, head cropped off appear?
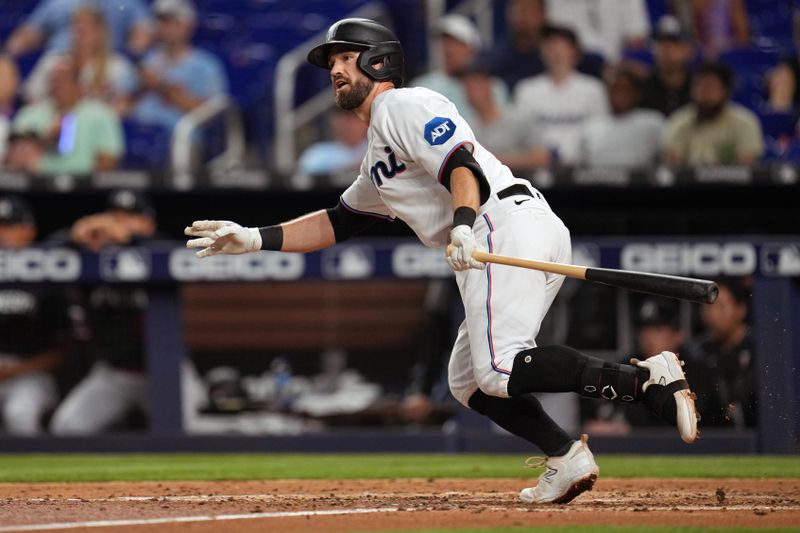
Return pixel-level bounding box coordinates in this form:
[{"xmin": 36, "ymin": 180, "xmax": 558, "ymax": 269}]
[{"xmin": 547, "ymin": 0, "xmax": 650, "ymax": 63}]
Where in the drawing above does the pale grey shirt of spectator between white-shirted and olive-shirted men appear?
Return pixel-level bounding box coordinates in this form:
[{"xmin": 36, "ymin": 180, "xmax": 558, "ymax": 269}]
[{"xmin": 581, "ymin": 109, "xmax": 664, "ymax": 168}]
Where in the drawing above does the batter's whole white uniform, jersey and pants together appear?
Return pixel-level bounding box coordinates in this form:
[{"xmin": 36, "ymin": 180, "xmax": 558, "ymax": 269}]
[{"xmin": 342, "ymin": 88, "xmax": 571, "ymax": 405}]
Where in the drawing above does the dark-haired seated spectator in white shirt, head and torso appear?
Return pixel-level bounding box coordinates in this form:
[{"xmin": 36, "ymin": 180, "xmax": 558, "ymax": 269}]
[{"xmin": 514, "ymin": 26, "xmax": 608, "ymax": 164}]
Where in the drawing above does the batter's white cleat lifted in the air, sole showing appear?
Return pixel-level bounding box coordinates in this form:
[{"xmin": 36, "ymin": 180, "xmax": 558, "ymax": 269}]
[{"xmin": 631, "ymin": 352, "xmax": 700, "ymax": 444}]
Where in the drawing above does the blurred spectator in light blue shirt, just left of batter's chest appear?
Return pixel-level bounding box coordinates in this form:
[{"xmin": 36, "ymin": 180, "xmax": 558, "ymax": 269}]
[{"xmin": 293, "ymin": 108, "xmax": 367, "ymax": 188}]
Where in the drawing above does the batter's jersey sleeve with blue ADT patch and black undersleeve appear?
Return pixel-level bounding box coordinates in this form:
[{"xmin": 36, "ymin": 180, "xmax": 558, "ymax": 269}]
[{"xmin": 378, "ymin": 97, "xmax": 491, "ymax": 204}]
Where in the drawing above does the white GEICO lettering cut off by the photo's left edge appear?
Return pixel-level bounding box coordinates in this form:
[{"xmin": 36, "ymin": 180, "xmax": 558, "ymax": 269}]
[{"xmin": 0, "ymin": 248, "xmax": 81, "ymax": 281}]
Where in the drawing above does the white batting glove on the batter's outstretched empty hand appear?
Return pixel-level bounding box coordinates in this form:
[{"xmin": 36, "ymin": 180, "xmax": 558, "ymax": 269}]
[{"xmin": 183, "ymin": 220, "xmax": 261, "ymax": 257}]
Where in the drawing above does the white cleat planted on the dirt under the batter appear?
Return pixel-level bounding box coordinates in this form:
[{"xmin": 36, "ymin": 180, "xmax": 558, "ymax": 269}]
[{"xmin": 519, "ymin": 434, "xmax": 600, "ymax": 503}]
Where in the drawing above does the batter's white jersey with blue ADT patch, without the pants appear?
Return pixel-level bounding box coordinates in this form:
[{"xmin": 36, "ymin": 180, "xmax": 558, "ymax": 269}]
[{"xmin": 342, "ymin": 87, "xmax": 514, "ymax": 247}]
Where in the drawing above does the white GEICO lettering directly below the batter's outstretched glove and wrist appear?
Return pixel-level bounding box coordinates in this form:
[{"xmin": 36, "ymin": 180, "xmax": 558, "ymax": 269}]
[{"xmin": 169, "ymin": 249, "xmax": 305, "ymax": 281}]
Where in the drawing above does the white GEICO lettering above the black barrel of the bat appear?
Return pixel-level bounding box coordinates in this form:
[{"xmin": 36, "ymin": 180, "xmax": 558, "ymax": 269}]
[{"xmin": 620, "ymin": 242, "xmax": 756, "ymax": 276}]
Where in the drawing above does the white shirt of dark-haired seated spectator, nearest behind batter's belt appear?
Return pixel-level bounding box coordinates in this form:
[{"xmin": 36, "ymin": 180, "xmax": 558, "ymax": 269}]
[{"xmin": 514, "ymin": 72, "xmax": 608, "ymax": 164}]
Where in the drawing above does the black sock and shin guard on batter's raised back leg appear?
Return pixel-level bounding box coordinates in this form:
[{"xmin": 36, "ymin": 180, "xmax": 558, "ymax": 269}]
[{"xmin": 508, "ymin": 346, "xmax": 650, "ymax": 402}]
